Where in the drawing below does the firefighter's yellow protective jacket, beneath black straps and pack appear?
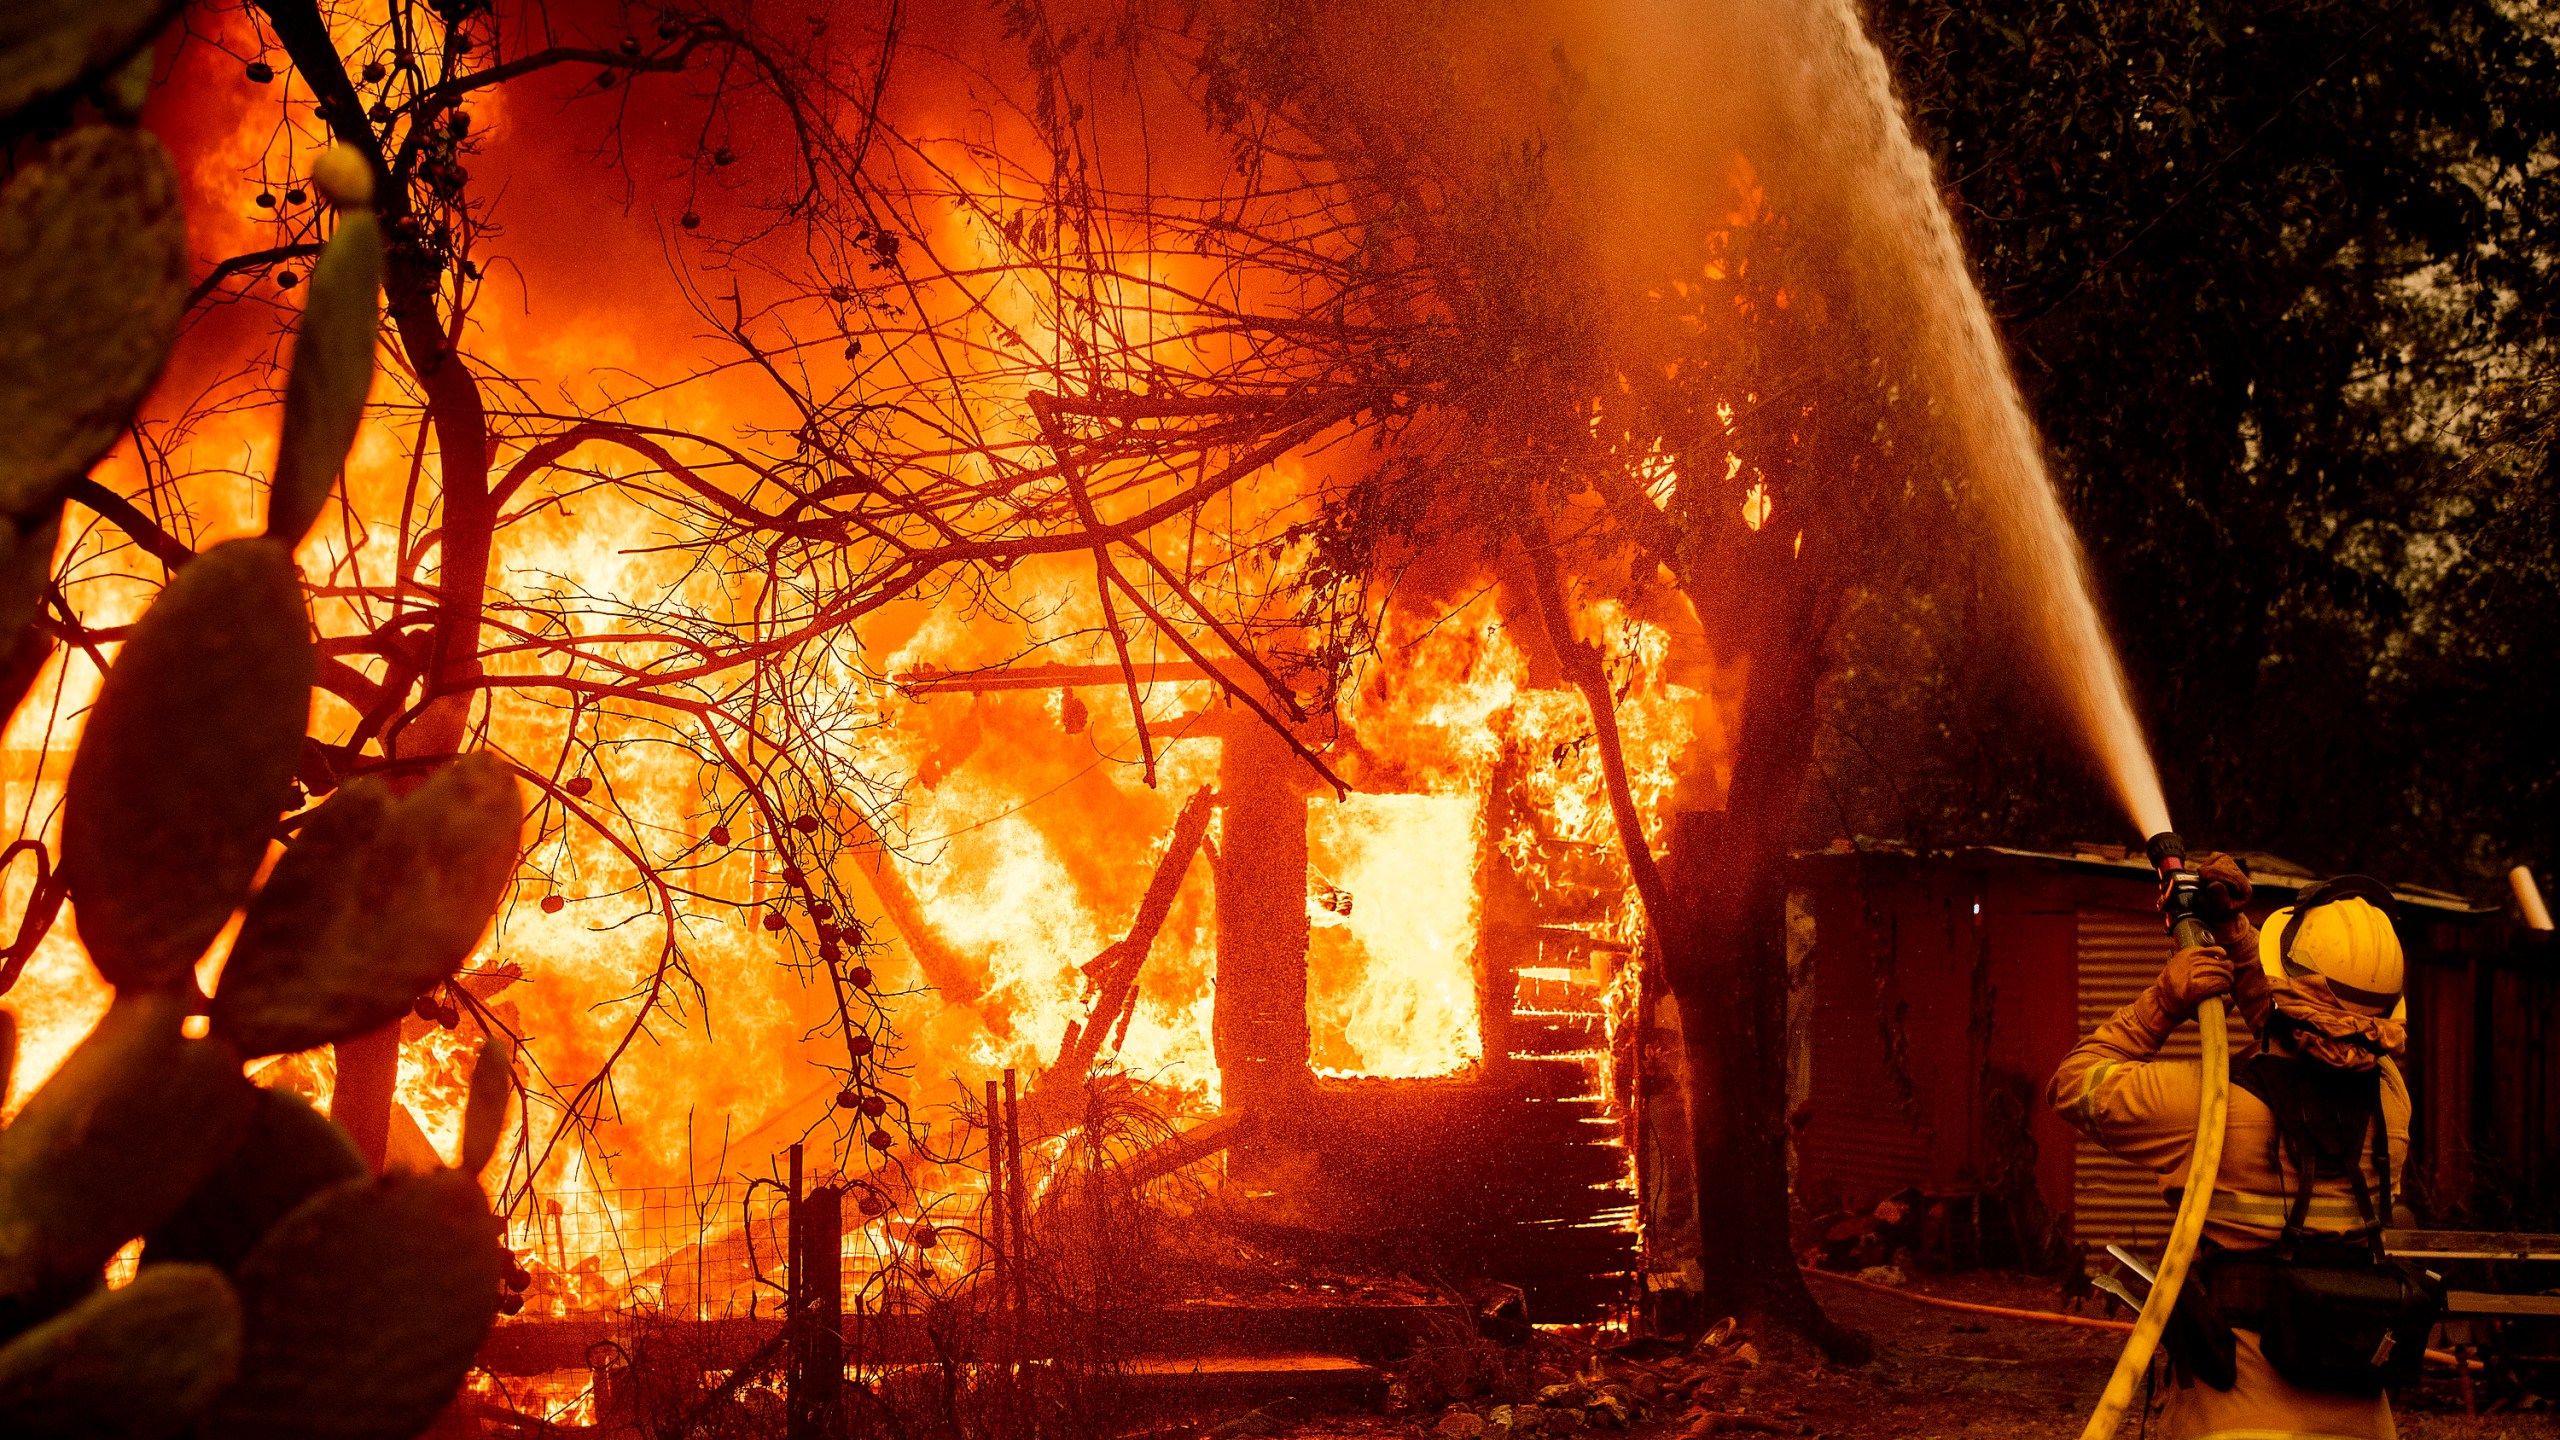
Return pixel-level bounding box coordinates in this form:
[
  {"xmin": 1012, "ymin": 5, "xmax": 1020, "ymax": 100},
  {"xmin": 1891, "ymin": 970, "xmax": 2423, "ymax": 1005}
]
[{"xmin": 2045, "ymin": 973, "xmax": 2409, "ymax": 1440}]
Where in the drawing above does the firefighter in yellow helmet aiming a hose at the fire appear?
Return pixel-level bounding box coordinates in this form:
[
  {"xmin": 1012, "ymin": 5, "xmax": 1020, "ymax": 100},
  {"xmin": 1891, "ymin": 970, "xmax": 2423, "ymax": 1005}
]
[{"xmin": 2048, "ymin": 856, "xmax": 2442, "ymax": 1440}]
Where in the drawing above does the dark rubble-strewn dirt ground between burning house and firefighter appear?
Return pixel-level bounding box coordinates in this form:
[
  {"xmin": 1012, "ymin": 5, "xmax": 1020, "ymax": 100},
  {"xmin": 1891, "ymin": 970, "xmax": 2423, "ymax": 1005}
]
[{"xmin": 1228, "ymin": 1273, "xmax": 2560, "ymax": 1440}]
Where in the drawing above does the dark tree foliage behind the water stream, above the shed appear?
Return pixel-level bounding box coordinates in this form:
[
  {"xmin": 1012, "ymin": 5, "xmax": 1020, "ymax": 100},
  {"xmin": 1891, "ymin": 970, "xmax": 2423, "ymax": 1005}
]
[{"xmin": 1807, "ymin": 0, "xmax": 2560, "ymax": 894}]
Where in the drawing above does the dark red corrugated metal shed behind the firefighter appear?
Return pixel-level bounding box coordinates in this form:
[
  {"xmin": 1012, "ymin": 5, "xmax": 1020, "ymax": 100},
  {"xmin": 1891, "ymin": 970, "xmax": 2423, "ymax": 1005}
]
[{"xmin": 1789, "ymin": 843, "xmax": 2508, "ymax": 1243}]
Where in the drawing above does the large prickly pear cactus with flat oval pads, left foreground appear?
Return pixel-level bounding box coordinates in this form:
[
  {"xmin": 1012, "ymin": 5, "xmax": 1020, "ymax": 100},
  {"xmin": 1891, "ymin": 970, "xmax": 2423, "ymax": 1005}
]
[{"xmin": 0, "ymin": 14, "xmax": 522, "ymax": 1440}]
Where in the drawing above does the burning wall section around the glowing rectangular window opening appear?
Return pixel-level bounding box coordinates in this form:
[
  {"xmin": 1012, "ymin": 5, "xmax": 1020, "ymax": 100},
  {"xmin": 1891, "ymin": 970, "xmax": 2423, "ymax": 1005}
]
[{"xmin": 909, "ymin": 625, "xmax": 1695, "ymax": 1320}]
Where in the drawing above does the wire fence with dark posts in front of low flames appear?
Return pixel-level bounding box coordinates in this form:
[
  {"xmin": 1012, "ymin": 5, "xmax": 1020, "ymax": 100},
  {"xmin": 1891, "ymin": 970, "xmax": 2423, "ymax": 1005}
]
[{"xmin": 471, "ymin": 1076, "xmax": 1224, "ymax": 1440}]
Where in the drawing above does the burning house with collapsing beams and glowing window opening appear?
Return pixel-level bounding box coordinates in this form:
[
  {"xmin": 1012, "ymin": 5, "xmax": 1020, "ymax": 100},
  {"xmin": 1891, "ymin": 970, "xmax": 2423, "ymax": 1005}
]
[{"xmin": 414, "ymin": 571, "xmax": 1718, "ymax": 1404}]
